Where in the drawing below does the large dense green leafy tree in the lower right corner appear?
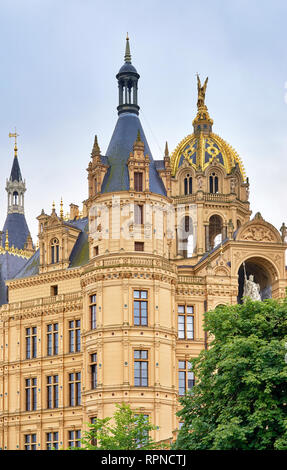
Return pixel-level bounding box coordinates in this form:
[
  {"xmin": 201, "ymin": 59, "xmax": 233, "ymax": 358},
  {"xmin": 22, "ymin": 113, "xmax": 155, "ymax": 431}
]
[{"xmin": 174, "ymin": 299, "xmax": 287, "ymax": 450}]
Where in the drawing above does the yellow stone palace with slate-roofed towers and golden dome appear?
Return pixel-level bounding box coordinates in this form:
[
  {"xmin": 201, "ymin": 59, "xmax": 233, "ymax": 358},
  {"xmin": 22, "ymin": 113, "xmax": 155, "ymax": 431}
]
[{"xmin": 0, "ymin": 38, "xmax": 287, "ymax": 450}]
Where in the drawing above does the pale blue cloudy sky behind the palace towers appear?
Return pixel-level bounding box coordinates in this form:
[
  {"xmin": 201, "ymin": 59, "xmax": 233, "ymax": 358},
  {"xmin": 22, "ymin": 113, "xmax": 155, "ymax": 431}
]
[{"xmin": 0, "ymin": 0, "xmax": 287, "ymax": 242}]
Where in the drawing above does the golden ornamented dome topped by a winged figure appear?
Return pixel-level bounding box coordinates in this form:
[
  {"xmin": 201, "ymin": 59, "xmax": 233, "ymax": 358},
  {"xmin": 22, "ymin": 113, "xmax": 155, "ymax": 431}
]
[{"xmin": 170, "ymin": 77, "xmax": 246, "ymax": 181}]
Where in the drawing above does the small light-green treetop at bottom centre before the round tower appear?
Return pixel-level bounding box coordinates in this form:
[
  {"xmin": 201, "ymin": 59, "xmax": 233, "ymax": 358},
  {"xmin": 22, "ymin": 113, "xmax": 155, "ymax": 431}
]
[{"xmin": 81, "ymin": 403, "xmax": 168, "ymax": 450}]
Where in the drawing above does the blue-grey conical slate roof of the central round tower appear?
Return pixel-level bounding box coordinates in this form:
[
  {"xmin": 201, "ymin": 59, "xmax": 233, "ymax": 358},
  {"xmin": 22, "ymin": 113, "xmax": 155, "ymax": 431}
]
[{"xmin": 102, "ymin": 113, "xmax": 166, "ymax": 196}]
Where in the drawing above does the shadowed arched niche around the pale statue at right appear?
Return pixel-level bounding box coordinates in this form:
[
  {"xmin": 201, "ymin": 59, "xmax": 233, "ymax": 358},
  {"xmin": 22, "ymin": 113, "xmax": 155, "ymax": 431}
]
[{"xmin": 237, "ymin": 257, "xmax": 276, "ymax": 303}]
